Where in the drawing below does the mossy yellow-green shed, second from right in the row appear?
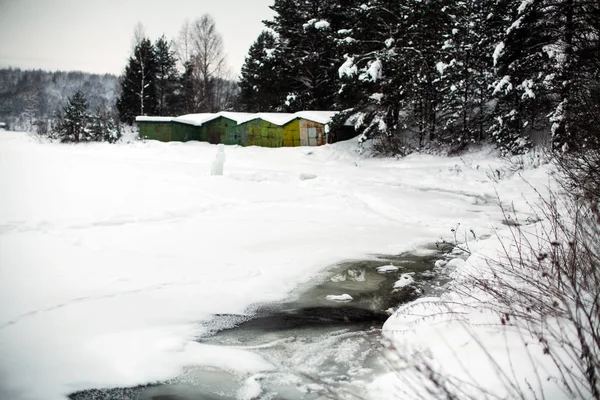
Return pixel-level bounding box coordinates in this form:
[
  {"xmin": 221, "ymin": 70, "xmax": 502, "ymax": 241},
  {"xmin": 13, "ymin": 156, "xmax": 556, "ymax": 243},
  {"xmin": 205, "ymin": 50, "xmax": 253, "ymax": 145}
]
[{"xmin": 238, "ymin": 113, "xmax": 295, "ymax": 147}]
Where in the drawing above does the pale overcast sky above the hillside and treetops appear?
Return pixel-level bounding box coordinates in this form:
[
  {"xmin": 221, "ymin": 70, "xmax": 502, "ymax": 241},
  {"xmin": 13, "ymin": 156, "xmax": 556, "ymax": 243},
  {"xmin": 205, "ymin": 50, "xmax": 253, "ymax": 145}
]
[{"xmin": 0, "ymin": 0, "xmax": 273, "ymax": 78}]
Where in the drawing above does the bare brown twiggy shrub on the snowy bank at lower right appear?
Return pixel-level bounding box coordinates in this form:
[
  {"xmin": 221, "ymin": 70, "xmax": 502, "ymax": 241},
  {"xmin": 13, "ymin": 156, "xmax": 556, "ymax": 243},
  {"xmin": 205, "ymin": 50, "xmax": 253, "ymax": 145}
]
[{"xmin": 390, "ymin": 172, "xmax": 600, "ymax": 399}]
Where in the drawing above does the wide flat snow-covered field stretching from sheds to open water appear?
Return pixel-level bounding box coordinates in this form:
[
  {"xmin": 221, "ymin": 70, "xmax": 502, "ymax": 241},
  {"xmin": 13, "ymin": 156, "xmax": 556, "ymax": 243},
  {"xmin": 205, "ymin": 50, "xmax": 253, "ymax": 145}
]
[{"xmin": 0, "ymin": 132, "xmax": 547, "ymax": 400}]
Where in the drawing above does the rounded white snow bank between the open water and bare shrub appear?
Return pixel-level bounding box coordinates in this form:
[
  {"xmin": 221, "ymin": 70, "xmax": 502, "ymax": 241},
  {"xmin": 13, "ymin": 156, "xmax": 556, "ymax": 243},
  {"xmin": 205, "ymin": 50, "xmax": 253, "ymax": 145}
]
[{"xmin": 369, "ymin": 161, "xmax": 570, "ymax": 399}]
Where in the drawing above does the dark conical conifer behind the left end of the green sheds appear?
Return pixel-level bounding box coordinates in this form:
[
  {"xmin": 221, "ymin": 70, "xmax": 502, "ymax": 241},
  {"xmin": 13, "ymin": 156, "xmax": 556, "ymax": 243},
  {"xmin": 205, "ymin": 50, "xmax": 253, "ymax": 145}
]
[{"xmin": 117, "ymin": 38, "xmax": 158, "ymax": 124}]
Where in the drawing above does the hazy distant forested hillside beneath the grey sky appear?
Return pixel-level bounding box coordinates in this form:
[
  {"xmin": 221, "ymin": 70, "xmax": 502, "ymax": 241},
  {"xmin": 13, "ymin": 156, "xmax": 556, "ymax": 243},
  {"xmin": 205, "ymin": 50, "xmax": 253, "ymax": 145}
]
[{"xmin": 0, "ymin": 68, "xmax": 119, "ymax": 131}]
